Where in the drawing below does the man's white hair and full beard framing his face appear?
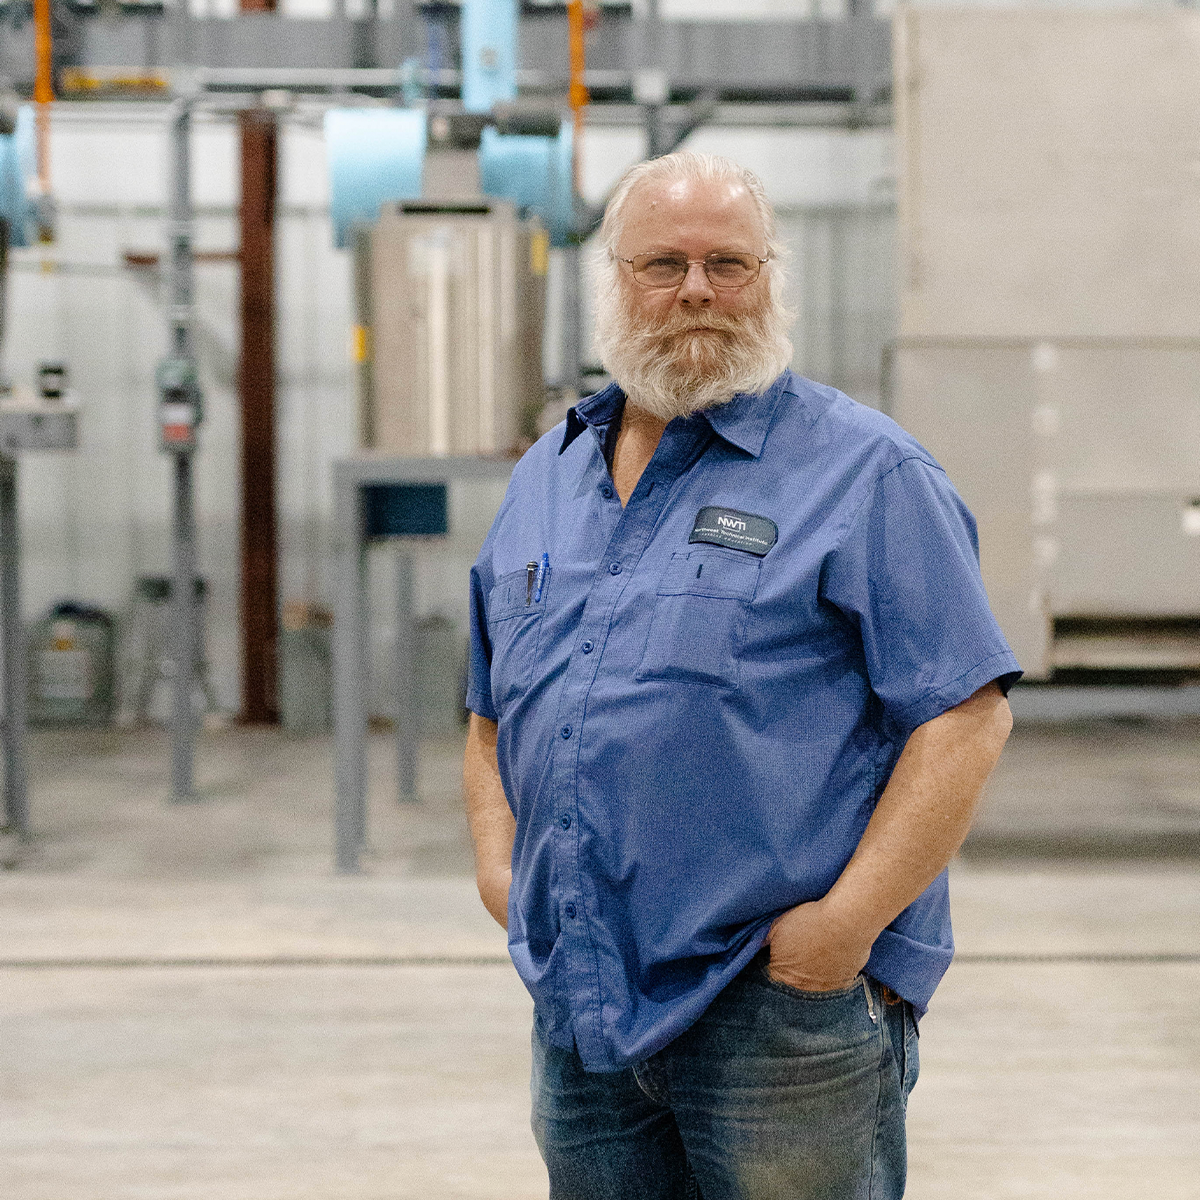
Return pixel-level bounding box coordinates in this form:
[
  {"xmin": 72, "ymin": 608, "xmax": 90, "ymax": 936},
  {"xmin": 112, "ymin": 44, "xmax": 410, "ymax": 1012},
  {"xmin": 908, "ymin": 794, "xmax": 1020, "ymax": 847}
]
[{"xmin": 592, "ymin": 150, "xmax": 792, "ymax": 420}]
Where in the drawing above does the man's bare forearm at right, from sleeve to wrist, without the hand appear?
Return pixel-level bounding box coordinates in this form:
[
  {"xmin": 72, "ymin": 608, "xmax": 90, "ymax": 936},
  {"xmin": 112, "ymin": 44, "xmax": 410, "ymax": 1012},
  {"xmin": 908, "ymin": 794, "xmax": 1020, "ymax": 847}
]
[{"xmin": 823, "ymin": 684, "xmax": 1013, "ymax": 942}]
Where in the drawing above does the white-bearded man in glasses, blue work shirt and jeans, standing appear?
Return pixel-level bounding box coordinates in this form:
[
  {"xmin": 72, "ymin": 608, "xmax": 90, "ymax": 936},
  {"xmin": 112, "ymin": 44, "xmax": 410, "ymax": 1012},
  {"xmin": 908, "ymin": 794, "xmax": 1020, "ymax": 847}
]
[{"xmin": 466, "ymin": 154, "xmax": 1020, "ymax": 1200}]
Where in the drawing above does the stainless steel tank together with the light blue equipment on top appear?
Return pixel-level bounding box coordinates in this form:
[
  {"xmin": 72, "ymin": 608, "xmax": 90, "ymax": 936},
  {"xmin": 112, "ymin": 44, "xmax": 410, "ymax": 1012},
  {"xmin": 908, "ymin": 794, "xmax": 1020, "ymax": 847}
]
[{"xmin": 325, "ymin": 0, "xmax": 580, "ymax": 456}]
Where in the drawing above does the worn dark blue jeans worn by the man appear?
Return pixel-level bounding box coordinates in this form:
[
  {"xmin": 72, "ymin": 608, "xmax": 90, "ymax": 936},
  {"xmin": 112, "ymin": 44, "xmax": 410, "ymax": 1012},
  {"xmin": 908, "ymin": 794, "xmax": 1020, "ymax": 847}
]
[{"xmin": 533, "ymin": 953, "xmax": 918, "ymax": 1200}]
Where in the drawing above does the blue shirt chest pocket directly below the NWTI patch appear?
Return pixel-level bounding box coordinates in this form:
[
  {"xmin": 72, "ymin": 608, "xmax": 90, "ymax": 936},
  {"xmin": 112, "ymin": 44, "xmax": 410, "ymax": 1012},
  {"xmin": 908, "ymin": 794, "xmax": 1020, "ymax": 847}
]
[{"xmin": 635, "ymin": 546, "xmax": 762, "ymax": 688}]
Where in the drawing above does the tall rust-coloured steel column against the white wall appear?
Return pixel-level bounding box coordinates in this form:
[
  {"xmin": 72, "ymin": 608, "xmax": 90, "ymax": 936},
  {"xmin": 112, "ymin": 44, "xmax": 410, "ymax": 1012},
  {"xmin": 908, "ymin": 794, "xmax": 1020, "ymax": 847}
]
[{"xmin": 238, "ymin": 108, "xmax": 278, "ymax": 724}]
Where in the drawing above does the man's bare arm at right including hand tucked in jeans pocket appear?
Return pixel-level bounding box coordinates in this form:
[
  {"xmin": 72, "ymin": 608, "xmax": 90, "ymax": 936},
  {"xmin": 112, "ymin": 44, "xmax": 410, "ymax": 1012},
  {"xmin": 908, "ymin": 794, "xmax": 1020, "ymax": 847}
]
[{"xmin": 768, "ymin": 683, "xmax": 1013, "ymax": 991}]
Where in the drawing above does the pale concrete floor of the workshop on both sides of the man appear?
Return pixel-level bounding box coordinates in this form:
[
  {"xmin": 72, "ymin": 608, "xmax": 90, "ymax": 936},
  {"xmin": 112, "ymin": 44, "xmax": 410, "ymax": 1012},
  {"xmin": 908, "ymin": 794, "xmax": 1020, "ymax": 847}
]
[{"xmin": 0, "ymin": 721, "xmax": 1200, "ymax": 1200}]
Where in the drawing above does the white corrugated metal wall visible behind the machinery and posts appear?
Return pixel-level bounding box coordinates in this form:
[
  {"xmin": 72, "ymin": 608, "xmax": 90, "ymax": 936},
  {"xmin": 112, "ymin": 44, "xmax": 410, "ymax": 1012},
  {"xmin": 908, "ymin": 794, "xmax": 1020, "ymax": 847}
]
[{"xmin": 4, "ymin": 104, "xmax": 894, "ymax": 709}]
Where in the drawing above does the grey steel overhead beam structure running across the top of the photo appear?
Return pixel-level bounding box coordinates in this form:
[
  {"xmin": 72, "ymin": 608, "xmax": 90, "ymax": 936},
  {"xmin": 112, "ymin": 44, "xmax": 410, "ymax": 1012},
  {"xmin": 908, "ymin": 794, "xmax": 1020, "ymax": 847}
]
[{"xmin": 0, "ymin": 0, "xmax": 892, "ymax": 129}]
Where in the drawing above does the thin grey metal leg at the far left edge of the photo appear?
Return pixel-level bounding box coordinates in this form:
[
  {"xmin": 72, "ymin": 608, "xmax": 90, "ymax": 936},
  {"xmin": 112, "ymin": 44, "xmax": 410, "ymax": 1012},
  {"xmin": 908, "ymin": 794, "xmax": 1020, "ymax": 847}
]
[{"xmin": 0, "ymin": 455, "xmax": 29, "ymax": 838}]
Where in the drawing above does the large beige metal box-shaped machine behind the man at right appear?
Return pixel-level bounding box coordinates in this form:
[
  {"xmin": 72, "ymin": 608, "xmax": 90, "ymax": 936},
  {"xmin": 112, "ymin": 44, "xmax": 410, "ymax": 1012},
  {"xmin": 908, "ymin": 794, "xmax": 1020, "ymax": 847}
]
[{"xmin": 893, "ymin": 10, "xmax": 1200, "ymax": 679}]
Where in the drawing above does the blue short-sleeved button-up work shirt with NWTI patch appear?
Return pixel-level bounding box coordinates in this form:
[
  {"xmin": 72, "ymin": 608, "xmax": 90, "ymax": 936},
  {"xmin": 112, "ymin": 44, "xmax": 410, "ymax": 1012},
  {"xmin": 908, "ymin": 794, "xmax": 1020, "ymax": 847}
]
[{"xmin": 467, "ymin": 372, "xmax": 1020, "ymax": 1070}]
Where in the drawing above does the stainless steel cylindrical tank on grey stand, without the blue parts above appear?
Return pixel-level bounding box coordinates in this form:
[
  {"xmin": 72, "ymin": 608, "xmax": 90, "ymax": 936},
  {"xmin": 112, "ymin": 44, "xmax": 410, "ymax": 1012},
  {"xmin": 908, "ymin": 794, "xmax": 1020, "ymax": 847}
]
[{"xmin": 356, "ymin": 199, "xmax": 547, "ymax": 455}]
